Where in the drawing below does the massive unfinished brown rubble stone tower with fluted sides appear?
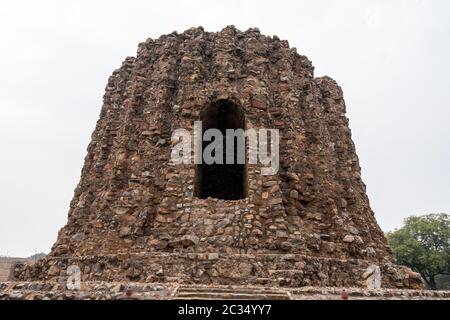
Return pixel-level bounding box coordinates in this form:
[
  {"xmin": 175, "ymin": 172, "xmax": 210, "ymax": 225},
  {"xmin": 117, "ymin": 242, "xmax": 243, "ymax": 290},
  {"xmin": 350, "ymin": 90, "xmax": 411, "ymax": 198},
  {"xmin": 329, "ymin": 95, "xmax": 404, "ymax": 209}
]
[{"xmin": 15, "ymin": 26, "xmax": 417, "ymax": 287}]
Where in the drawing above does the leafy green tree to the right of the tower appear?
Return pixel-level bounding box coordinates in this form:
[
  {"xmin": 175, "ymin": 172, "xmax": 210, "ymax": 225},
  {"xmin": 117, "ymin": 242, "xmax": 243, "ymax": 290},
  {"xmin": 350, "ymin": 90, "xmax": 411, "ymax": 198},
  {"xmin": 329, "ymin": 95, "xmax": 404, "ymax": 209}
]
[{"xmin": 386, "ymin": 213, "xmax": 450, "ymax": 290}]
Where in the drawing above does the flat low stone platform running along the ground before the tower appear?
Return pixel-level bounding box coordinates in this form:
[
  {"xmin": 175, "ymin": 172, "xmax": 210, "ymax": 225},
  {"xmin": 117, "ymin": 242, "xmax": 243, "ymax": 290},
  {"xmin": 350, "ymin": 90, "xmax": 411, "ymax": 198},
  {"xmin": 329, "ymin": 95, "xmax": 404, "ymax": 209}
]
[{"xmin": 0, "ymin": 282, "xmax": 450, "ymax": 300}]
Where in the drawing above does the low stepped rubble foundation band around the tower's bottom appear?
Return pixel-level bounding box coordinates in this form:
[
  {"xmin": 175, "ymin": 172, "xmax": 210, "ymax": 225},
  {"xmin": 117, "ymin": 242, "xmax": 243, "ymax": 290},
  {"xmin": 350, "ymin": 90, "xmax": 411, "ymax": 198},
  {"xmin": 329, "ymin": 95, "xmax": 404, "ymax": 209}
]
[{"xmin": 15, "ymin": 252, "xmax": 423, "ymax": 288}]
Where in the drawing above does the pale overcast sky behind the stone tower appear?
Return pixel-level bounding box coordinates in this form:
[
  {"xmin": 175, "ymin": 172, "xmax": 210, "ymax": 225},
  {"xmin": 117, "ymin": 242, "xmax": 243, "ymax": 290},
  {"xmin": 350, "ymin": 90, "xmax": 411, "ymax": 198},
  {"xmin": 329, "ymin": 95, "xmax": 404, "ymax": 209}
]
[{"xmin": 0, "ymin": 0, "xmax": 450, "ymax": 256}]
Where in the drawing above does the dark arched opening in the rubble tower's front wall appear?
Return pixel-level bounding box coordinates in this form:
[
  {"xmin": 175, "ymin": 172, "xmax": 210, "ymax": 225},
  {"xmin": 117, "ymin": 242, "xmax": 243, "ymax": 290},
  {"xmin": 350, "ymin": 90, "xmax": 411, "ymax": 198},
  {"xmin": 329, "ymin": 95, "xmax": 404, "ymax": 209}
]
[{"xmin": 195, "ymin": 100, "xmax": 247, "ymax": 200}]
